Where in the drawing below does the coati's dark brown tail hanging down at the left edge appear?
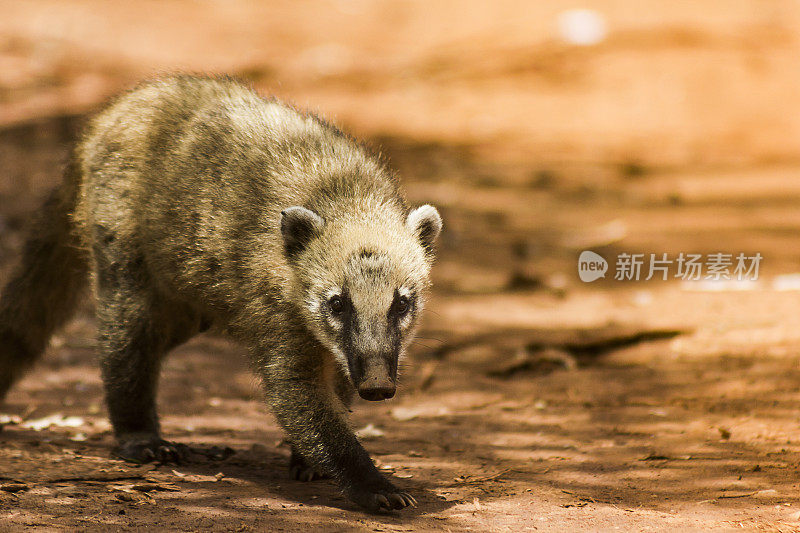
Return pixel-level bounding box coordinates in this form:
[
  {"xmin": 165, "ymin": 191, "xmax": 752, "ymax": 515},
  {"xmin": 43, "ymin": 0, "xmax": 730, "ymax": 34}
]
[{"xmin": 0, "ymin": 164, "xmax": 87, "ymax": 400}]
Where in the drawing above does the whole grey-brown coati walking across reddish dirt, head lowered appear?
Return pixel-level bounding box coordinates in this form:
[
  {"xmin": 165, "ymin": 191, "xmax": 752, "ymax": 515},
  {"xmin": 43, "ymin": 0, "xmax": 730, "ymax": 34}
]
[{"xmin": 0, "ymin": 76, "xmax": 442, "ymax": 511}]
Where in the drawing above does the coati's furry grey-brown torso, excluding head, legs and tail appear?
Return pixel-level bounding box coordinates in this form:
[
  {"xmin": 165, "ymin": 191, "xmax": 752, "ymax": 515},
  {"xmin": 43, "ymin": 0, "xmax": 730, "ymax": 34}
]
[{"xmin": 75, "ymin": 76, "xmax": 406, "ymax": 318}]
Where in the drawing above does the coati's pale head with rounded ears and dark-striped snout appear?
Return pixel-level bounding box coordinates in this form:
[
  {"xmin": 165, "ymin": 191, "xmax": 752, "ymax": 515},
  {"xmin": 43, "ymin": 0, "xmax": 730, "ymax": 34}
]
[{"xmin": 281, "ymin": 205, "xmax": 442, "ymax": 400}]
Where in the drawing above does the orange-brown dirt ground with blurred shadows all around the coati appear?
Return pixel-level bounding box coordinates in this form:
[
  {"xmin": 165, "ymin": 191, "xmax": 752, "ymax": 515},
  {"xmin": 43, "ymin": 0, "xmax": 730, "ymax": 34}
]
[{"xmin": 0, "ymin": 0, "xmax": 800, "ymax": 532}]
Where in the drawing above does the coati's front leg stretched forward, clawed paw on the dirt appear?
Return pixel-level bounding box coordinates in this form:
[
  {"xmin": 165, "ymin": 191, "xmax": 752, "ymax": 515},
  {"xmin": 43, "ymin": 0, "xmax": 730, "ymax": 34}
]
[{"xmin": 262, "ymin": 344, "xmax": 416, "ymax": 511}]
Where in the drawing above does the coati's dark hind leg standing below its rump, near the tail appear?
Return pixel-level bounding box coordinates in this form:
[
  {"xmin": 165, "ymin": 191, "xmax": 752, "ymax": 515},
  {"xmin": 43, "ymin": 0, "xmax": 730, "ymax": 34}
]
[{"xmin": 95, "ymin": 240, "xmax": 198, "ymax": 463}]
